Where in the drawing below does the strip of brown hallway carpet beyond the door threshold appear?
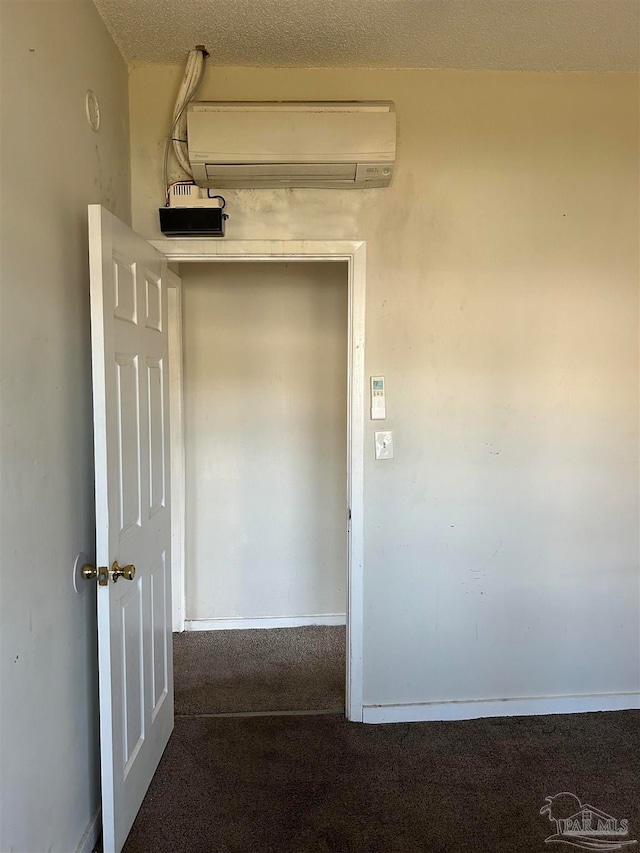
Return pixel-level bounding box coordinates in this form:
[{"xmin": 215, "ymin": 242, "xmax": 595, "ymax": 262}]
[{"xmin": 173, "ymin": 626, "xmax": 345, "ymax": 714}]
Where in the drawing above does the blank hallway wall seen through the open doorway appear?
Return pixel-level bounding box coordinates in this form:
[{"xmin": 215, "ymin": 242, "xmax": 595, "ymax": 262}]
[{"xmin": 180, "ymin": 263, "xmax": 347, "ymax": 621}]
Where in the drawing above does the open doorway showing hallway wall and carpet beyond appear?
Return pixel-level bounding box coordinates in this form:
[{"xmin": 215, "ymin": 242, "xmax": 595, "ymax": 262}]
[{"xmin": 174, "ymin": 261, "xmax": 348, "ymax": 715}]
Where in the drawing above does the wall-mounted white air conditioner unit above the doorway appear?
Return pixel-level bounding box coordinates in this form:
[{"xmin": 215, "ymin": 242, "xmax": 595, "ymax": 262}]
[{"xmin": 187, "ymin": 101, "xmax": 396, "ymax": 189}]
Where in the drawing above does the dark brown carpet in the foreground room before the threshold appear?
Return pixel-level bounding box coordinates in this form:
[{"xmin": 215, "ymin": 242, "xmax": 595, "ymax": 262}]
[{"xmin": 124, "ymin": 711, "xmax": 640, "ymax": 853}]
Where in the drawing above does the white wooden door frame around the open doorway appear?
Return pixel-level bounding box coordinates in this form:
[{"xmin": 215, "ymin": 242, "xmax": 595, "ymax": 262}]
[{"xmin": 149, "ymin": 239, "xmax": 366, "ymax": 722}]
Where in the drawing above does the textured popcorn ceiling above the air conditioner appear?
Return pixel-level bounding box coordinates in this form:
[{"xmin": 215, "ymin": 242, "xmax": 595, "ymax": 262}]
[{"xmin": 94, "ymin": 0, "xmax": 640, "ymax": 71}]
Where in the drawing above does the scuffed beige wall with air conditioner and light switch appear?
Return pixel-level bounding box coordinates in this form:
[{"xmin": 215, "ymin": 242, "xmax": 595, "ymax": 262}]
[{"xmin": 130, "ymin": 66, "xmax": 639, "ymax": 703}]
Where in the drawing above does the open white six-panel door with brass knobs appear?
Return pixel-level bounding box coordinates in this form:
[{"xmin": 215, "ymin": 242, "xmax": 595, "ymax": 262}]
[{"xmin": 89, "ymin": 205, "xmax": 173, "ymax": 853}]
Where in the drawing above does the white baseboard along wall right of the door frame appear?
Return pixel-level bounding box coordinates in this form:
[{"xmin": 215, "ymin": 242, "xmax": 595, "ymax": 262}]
[{"xmin": 363, "ymin": 693, "xmax": 640, "ymax": 723}]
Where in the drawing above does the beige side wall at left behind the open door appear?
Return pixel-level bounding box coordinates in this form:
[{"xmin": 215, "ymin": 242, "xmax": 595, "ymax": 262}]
[{"xmin": 0, "ymin": 0, "xmax": 130, "ymax": 853}]
